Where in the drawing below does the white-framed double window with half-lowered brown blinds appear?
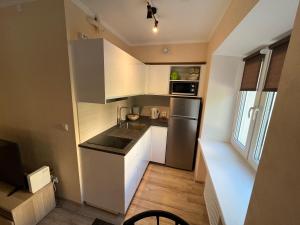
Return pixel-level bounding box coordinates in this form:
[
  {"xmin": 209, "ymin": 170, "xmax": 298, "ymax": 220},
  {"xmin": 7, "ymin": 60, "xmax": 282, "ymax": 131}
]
[{"xmin": 232, "ymin": 37, "xmax": 289, "ymax": 168}]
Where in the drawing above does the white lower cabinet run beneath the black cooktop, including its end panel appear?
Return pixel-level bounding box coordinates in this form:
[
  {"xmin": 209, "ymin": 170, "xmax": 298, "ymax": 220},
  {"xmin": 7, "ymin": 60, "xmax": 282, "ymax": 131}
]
[{"xmin": 80, "ymin": 128, "xmax": 151, "ymax": 214}]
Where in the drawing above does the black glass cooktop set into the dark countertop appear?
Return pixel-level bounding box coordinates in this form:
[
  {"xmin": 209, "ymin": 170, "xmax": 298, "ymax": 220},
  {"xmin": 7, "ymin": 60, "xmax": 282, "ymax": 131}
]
[{"xmin": 87, "ymin": 135, "xmax": 132, "ymax": 149}]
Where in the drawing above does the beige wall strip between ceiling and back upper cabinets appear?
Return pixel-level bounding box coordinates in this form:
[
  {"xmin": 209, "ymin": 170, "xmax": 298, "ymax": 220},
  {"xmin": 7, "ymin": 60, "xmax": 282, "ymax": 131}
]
[{"xmin": 131, "ymin": 43, "xmax": 207, "ymax": 63}]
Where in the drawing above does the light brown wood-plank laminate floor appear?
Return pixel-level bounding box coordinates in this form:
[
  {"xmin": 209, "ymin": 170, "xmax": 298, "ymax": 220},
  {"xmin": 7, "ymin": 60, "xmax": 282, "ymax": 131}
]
[{"xmin": 40, "ymin": 164, "xmax": 209, "ymax": 225}]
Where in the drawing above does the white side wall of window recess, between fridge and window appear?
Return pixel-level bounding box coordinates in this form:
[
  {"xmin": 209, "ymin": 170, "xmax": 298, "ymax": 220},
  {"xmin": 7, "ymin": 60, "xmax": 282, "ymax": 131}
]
[{"xmin": 201, "ymin": 55, "xmax": 244, "ymax": 142}]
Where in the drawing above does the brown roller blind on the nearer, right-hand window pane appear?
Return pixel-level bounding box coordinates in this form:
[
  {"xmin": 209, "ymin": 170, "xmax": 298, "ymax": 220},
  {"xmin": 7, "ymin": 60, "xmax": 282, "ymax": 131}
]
[{"xmin": 263, "ymin": 37, "xmax": 289, "ymax": 91}]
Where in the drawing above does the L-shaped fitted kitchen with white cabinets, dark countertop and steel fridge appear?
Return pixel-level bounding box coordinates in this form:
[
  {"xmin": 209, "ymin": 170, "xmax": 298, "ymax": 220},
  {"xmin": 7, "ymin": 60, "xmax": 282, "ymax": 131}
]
[{"xmin": 72, "ymin": 36, "xmax": 205, "ymax": 214}]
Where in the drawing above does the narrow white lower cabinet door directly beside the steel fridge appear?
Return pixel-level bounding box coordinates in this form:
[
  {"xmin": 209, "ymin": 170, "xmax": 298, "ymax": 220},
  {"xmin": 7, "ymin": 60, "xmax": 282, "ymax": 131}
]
[{"xmin": 151, "ymin": 126, "xmax": 168, "ymax": 164}]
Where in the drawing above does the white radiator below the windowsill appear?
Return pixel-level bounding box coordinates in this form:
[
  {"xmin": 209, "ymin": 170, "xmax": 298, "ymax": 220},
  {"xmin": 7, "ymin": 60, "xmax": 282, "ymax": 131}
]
[{"xmin": 204, "ymin": 174, "xmax": 223, "ymax": 225}]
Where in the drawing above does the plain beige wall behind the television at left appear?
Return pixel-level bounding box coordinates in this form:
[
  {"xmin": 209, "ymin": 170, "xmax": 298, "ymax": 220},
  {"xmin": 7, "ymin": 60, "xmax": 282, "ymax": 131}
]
[{"xmin": 0, "ymin": 0, "xmax": 80, "ymax": 201}]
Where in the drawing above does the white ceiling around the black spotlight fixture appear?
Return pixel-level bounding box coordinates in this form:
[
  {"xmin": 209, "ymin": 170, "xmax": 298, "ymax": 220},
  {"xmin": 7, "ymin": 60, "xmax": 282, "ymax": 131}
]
[{"xmin": 76, "ymin": 0, "xmax": 230, "ymax": 45}]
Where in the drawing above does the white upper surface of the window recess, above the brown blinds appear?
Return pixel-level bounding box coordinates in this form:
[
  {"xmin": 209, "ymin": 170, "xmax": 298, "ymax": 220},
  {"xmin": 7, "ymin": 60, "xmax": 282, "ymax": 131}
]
[{"xmin": 215, "ymin": 0, "xmax": 299, "ymax": 56}]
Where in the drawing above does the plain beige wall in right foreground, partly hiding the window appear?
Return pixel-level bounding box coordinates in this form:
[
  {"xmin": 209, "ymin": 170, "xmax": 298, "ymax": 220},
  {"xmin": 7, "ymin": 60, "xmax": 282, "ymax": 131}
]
[{"xmin": 245, "ymin": 4, "xmax": 300, "ymax": 225}]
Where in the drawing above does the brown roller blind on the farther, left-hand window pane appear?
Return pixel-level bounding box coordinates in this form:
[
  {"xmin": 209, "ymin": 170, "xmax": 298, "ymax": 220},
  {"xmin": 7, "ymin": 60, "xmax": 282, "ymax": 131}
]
[{"xmin": 240, "ymin": 53, "xmax": 263, "ymax": 91}]
